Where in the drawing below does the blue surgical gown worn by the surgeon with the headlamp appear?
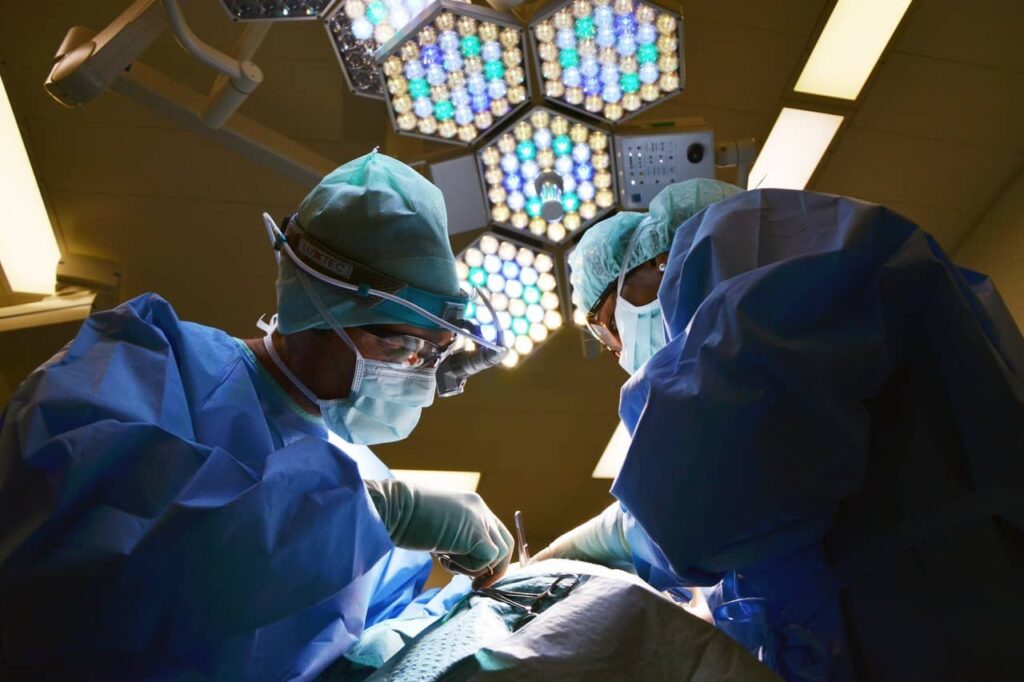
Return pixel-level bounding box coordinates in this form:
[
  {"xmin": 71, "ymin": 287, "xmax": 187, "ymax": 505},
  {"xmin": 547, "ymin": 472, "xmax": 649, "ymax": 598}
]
[{"xmin": 0, "ymin": 295, "xmax": 458, "ymax": 680}]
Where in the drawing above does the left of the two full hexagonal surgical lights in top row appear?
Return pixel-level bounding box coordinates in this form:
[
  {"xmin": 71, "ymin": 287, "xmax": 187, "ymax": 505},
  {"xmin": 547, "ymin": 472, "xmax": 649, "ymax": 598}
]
[{"xmin": 376, "ymin": 0, "xmax": 529, "ymax": 144}]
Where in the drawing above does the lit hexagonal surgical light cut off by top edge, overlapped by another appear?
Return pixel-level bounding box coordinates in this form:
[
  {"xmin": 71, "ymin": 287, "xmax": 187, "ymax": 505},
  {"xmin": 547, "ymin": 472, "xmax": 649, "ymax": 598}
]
[{"xmin": 325, "ymin": 0, "xmax": 468, "ymax": 97}]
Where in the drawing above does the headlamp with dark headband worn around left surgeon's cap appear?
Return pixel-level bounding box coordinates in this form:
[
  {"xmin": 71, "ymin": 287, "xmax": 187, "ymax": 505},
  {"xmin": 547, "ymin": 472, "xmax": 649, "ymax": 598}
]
[{"xmin": 263, "ymin": 213, "xmax": 509, "ymax": 397}]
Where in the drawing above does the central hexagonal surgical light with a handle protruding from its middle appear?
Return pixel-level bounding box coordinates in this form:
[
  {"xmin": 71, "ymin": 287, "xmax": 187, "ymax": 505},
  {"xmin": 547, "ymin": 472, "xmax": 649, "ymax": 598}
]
[{"xmin": 477, "ymin": 106, "xmax": 616, "ymax": 244}]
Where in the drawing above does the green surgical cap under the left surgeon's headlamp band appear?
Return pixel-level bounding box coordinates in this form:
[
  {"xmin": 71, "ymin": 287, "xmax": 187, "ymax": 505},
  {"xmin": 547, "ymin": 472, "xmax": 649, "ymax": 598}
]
[{"xmin": 278, "ymin": 152, "xmax": 459, "ymax": 334}]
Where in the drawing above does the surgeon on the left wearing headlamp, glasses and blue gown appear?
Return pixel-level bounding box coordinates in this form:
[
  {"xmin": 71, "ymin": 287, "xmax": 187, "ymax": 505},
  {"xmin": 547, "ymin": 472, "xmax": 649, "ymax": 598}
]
[{"xmin": 0, "ymin": 153, "xmax": 513, "ymax": 680}]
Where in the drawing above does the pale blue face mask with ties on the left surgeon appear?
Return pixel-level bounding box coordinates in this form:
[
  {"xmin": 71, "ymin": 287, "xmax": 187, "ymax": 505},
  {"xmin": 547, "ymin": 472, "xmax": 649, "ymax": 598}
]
[{"xmin": 263, "ymin": 309, "xmax": 436, "ymax": 445}]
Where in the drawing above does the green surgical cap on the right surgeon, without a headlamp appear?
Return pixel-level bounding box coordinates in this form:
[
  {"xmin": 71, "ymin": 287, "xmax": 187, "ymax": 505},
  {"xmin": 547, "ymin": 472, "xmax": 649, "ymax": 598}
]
[{"xmin": 569, "ymin": 178, "xmax": 742, "ymax": 310}]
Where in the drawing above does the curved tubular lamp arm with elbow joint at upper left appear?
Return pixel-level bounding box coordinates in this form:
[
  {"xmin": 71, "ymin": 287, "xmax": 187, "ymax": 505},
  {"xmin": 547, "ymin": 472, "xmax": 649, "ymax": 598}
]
[{"xmin": 163, "ymin": 0, "xmax": 269, "ymax": 128}]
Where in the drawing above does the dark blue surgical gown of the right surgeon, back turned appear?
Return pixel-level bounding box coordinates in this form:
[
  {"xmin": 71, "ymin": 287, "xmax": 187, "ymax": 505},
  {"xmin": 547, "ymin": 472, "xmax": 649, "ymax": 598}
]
[{"xmin": 613, "ymin": 189, "xmax": 1024, "ymax": 680}]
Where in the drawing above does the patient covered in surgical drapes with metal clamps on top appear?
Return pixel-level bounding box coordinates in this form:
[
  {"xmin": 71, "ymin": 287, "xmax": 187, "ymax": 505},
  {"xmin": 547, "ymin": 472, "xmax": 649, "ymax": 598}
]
[{"xmin": 324, "ymin": 559, "xmax": 778, "ymax": 682}]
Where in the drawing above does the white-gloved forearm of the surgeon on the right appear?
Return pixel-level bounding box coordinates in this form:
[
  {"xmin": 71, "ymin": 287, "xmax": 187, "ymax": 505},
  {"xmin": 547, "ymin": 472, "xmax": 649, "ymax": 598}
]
[{"xmin": 532, "ymin": 502, "xmax": 636, "ymax": 573}]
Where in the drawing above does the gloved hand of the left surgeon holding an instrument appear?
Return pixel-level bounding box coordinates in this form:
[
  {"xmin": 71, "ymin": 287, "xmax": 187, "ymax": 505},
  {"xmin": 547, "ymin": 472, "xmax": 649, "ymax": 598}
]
[{"xmin": 365, "ymin": 480, "xmax": 515, "ymax": 588}]
